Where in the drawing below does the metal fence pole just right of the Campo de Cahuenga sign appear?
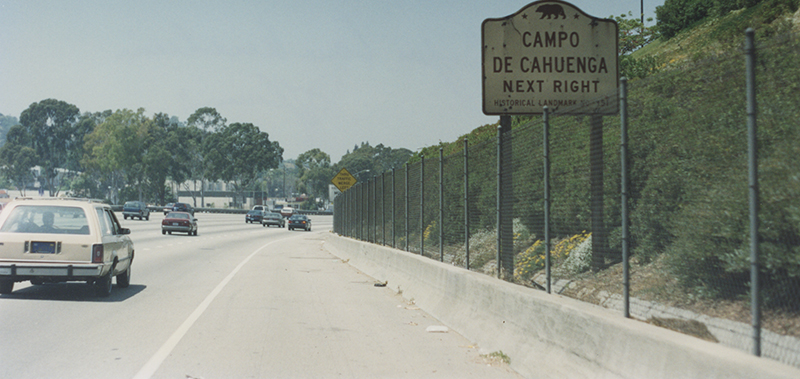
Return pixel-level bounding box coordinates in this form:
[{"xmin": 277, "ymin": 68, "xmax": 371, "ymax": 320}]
[{"xmin": 619, "ymin": 77, "xmax": 631, "ymax": 318}]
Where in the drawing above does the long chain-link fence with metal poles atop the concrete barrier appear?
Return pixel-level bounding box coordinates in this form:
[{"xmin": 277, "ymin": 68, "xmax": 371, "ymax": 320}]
[{"xmin": 334, "ymin": 31, "xmax": 800, "ymax": 366}]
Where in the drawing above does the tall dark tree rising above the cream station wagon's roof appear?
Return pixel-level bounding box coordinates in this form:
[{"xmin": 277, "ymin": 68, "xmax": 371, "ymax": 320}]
[{"xmin": 19, "ymin": 99, "xmax": 80, "ymax": 196}]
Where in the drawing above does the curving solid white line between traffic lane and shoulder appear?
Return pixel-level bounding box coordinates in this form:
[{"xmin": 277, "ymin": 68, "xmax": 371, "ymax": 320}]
[{"xmin": 133, "ymin": 237, "xmax": 292, "ymax": 379}]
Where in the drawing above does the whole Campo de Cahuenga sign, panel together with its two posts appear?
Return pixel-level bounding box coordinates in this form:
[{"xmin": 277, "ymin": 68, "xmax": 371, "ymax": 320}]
[{"xmin": 481, "ymin": 0, "xmax": 619, "ymax": 276}]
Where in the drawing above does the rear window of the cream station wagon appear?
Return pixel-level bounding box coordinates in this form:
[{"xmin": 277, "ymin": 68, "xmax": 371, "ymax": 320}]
[{"xmin": 0, "ymin": 205, "xmax": 89, "ymax": 234}]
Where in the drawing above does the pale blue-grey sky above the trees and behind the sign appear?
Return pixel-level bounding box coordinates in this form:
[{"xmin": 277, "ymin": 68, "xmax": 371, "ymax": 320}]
[{"xmin": 0, "ymin": 0, "xmax": 664, "ymax": 163}]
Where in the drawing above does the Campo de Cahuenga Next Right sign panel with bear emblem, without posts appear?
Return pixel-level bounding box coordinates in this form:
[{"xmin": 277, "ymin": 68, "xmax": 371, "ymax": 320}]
[{"xmin": 481, "ymin": 0, "xmax": 619, "ymax": 115}]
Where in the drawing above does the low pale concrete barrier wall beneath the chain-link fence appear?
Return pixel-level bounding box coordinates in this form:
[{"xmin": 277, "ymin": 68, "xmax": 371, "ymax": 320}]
[{"xmin": 325, "ymin": 234, "xmax": 800, "ymax": 379}]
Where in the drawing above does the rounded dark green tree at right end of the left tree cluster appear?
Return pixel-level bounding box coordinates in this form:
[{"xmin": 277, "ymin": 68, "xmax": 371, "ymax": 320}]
[{"xmin": 206, "ymin": 123, "xmax": 283, "ymax": 208}]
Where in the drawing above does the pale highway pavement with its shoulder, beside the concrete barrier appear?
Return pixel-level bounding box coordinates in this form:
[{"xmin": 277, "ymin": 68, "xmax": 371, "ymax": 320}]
[{"xmin": 0, "ymin": 213, "xmax": 519, "ymax": 379}]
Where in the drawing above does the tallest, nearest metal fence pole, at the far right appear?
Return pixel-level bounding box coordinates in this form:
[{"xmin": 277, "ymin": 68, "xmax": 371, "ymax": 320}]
[{"xmin": 745, "ymin": 28, "xmax": 761, "ymax": 356}]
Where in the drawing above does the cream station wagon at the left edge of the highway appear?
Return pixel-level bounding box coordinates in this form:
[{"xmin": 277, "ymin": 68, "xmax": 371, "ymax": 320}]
[{"xmin": 0, "ymin": 198, "xmax": 134, "ymax": 297}]
